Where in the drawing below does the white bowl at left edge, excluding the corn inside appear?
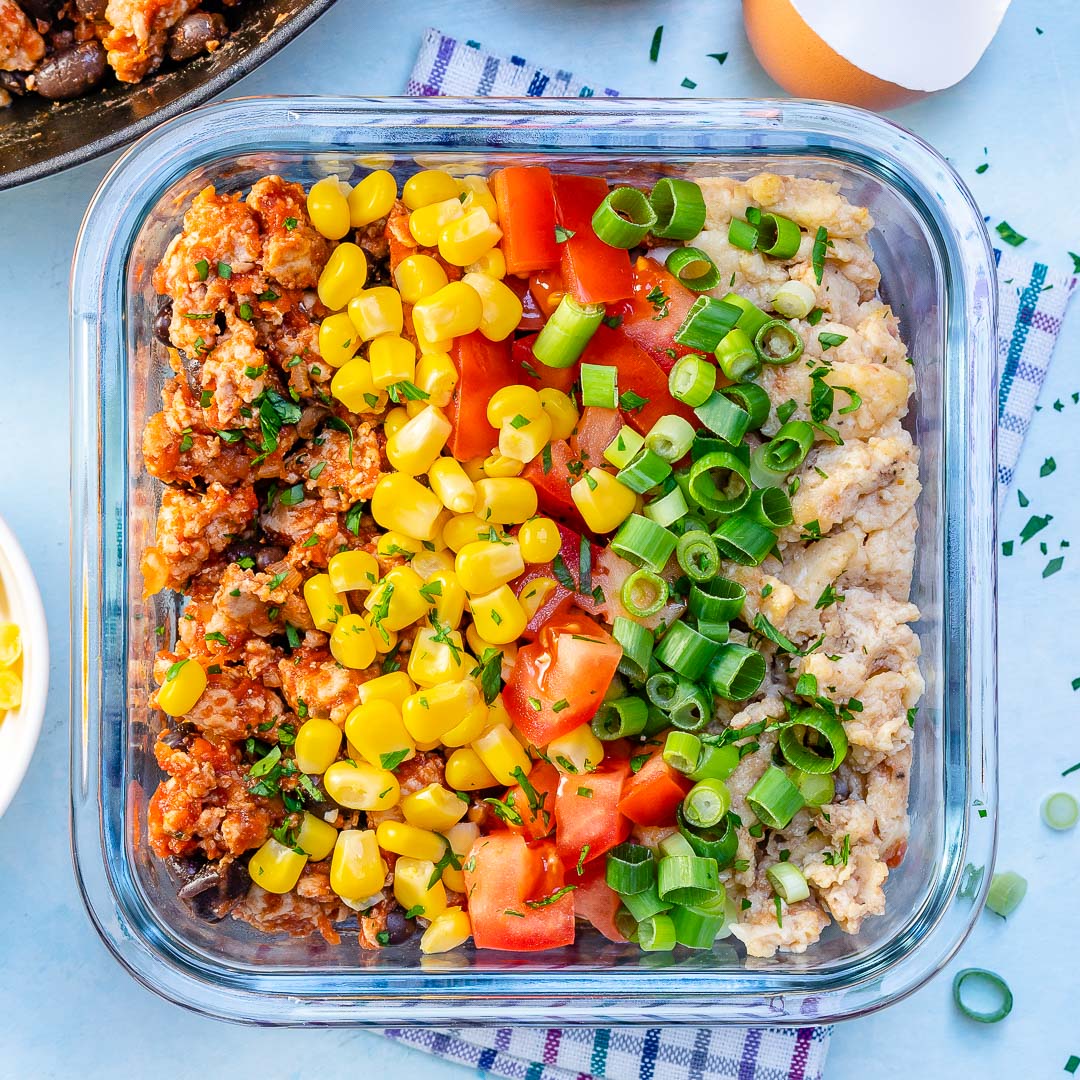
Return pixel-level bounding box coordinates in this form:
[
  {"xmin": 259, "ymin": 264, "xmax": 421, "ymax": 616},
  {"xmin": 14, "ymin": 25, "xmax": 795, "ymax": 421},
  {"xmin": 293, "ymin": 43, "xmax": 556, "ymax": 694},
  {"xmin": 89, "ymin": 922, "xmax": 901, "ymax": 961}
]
[{"xmin": 0, "ymin": 517, "xmax": 49, "ymax": 818}]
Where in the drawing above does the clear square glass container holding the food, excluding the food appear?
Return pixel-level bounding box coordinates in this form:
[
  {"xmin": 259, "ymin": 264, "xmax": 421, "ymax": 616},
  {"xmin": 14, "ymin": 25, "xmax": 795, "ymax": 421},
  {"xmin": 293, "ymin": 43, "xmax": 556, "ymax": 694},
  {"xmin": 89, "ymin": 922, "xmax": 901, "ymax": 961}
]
[{"xmin": 65, "ymin": 97, "xmax": 997, "ymax": 1025}]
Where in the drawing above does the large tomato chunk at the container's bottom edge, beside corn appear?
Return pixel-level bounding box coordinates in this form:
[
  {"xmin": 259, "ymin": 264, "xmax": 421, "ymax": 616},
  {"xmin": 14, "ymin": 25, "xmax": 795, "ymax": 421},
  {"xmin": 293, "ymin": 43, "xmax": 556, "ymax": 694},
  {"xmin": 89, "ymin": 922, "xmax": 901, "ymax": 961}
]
[{"xmin": 464, "ymin": 831, "xmax": 573, "ymax": 951}]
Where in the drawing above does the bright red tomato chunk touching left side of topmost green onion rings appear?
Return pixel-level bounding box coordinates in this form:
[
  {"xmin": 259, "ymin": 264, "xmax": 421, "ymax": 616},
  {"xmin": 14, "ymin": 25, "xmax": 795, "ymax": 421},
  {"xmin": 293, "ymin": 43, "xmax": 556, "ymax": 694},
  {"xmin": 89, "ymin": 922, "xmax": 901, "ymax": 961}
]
[{"xmin": 555, "ymin": 176, "xmax": 633, "ymax": 303}]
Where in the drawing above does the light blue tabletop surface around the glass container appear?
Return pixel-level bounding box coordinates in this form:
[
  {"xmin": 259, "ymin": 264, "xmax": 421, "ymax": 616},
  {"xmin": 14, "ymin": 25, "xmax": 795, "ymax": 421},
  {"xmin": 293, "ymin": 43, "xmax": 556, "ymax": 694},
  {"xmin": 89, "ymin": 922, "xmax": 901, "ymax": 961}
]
[{"xmin": 0, "ymin": 0, "xmax": 1080, "ymax": 1080}]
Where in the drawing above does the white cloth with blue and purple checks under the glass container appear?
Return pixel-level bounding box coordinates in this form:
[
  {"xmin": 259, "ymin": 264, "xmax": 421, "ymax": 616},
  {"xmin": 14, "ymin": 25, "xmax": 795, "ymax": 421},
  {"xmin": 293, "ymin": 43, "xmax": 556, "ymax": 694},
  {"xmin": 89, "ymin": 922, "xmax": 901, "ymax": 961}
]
[{"xmin": 399, "ymin": 29, "xmax": 1078, "ymax": 1080}]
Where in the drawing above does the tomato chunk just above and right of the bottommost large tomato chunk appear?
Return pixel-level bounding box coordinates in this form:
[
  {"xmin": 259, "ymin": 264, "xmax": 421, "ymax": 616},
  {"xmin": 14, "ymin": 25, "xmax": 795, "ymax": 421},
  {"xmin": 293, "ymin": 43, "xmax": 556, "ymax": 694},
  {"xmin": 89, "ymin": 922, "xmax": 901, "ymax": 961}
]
[{"xmin": 555, "ymin": 758, "xmax": 630, "ymax": 880}]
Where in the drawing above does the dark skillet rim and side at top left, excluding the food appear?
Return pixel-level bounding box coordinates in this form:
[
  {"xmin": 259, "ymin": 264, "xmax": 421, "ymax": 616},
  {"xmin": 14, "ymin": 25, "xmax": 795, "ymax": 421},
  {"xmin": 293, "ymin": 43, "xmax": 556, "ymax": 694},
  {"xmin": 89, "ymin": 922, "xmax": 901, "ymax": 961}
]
[{"xmin": 0, "ymin": 0, "xmax": 334, "ymax": 191}]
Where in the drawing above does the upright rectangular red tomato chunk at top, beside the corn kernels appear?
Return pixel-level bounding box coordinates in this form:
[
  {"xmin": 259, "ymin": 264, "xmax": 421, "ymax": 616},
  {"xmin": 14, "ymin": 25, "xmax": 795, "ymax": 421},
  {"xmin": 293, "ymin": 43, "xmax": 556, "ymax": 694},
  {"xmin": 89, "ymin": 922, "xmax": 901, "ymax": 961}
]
[{"xmin": 490, "ymin": 165, "xmax": 559, "ymax": 274}]
